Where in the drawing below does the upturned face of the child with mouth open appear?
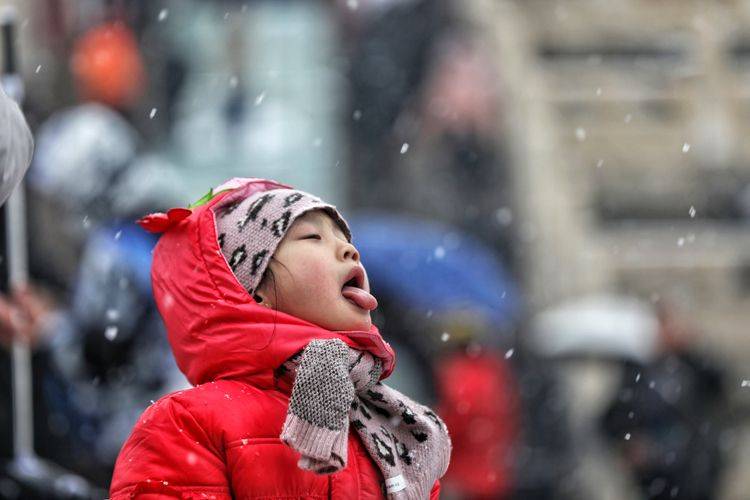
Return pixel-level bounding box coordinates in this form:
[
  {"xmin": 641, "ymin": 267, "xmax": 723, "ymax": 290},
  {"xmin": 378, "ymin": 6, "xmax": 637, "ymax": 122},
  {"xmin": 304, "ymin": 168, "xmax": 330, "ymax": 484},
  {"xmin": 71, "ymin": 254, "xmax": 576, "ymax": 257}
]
[{"xmin": 255, "ymin": 210, "xmax": 377, "ymax": 331}]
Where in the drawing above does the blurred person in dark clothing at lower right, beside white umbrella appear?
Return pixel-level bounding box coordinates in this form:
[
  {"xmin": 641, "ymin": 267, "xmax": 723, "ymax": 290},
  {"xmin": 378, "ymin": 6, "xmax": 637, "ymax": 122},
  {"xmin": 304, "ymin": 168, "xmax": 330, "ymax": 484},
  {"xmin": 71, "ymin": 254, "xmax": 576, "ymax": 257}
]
[{"xmin": 601, "ymin": 303, "xmax": 726, "ymax": 500}]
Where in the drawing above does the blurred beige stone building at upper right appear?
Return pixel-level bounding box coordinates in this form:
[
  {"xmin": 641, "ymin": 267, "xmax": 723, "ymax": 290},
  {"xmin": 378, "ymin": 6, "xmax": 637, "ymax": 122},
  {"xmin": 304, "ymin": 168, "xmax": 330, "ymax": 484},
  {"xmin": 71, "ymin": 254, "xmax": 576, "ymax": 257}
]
[{"xmin": 466, "ymin": 0, "xmax": 750, "ymax": 499}]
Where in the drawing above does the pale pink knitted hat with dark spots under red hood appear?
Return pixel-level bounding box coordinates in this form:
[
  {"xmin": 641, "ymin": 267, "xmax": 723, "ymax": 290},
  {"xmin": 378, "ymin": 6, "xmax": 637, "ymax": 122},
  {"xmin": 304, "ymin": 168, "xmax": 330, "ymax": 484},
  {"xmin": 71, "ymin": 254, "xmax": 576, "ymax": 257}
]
[{"xmin": 215, "ymin": 189, "xmax": 352, "ymax": 295}]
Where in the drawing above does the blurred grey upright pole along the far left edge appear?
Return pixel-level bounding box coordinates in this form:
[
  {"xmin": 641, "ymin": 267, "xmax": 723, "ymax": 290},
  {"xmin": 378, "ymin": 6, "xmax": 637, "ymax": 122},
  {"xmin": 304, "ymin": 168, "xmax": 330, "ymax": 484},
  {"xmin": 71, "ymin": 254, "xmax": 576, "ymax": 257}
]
[{"xmin": 0, "ymin": 3, "xmax": 34, "ymax": 460}]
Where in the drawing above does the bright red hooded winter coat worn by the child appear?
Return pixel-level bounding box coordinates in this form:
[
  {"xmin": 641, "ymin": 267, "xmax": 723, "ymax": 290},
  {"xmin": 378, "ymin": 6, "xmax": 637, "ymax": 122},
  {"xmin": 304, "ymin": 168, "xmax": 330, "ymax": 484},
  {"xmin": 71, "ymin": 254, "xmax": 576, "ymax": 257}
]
[{"xmin": 110, "ymin": 180, "xmax": 440, "ymax": 500}]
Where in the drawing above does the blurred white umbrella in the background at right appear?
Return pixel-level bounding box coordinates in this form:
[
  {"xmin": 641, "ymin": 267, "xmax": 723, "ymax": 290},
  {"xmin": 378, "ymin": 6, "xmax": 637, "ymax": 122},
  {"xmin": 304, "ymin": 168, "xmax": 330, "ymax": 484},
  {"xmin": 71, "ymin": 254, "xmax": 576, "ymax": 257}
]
[{"xmin": 530, "ymin": 295, "xmax": 659, "ymax": 361}]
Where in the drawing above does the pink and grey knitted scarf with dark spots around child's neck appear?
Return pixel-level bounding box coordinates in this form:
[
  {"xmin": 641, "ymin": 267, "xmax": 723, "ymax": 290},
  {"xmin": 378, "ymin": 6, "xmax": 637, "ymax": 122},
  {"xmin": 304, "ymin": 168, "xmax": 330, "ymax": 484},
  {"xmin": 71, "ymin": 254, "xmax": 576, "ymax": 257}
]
[{"xmin": 279, "ymin": 339, "xmax": 451, "ymax": 500}]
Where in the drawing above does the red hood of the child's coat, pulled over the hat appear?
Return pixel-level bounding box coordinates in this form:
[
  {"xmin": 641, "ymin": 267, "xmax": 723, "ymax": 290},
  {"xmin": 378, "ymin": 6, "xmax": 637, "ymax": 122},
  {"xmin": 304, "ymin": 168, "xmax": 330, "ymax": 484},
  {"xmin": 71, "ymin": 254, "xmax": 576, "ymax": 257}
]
[{"xmin": 142, "ymin": 179, "xmax": 395, "ymax": 387}]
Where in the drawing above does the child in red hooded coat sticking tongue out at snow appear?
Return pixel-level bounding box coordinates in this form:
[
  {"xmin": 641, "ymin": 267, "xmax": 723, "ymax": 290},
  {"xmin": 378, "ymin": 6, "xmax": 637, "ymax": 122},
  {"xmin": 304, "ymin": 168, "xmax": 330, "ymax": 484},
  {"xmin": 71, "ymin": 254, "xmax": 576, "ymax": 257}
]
[{"xmin": 110, "ymin": 179, "xmax": 451, "ymax": 500}]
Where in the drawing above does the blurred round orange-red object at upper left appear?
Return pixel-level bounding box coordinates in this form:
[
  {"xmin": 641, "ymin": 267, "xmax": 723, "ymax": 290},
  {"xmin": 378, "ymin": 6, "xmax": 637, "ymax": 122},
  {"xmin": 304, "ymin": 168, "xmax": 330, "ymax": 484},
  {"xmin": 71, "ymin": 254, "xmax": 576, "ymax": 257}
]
[{"xmin": 71, "ymin": 22, "xmax": 145, "ymax": 108}]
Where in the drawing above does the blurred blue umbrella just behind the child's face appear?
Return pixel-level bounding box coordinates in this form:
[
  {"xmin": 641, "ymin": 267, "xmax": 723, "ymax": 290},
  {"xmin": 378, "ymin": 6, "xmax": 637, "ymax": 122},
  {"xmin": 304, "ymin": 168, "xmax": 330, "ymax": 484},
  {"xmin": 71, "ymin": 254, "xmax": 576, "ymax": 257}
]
[{"xmin": 348, "ymin": 213, "xmax": 520, "ymax": 328}]
